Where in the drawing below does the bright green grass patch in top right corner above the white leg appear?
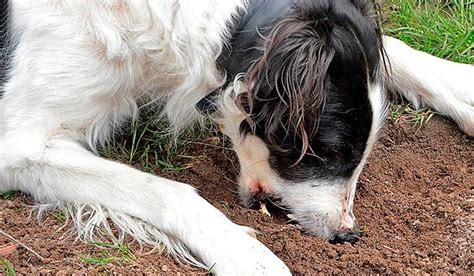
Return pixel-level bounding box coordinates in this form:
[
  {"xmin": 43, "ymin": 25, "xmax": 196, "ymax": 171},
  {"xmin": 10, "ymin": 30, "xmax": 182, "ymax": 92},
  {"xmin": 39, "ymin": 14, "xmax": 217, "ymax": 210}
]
[{"xmin": 385, "ymin": 0, "xmax": 474, "ymax": 64}]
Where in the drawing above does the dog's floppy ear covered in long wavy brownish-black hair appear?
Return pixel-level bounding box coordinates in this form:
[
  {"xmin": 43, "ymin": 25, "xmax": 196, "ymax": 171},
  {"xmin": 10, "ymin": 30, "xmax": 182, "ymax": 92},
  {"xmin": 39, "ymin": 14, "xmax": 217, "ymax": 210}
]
[{"xmin": 241, "ymin": 8, "xmax": 335, "ymax": 162}]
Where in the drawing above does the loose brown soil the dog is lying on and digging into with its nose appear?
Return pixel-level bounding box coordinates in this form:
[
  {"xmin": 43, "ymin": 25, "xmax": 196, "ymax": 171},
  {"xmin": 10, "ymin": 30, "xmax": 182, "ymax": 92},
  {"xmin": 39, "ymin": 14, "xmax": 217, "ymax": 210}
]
[{"xmin": 0, "ymin": 113, "xmax": 474, "ymax": 274}]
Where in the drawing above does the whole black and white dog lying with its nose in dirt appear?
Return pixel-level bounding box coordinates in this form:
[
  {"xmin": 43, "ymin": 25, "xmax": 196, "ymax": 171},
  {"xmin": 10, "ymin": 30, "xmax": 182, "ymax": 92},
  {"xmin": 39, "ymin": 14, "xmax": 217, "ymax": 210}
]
[{"xmin": 0, "ymin": 0, "xmax": 474, "ymax": 275}]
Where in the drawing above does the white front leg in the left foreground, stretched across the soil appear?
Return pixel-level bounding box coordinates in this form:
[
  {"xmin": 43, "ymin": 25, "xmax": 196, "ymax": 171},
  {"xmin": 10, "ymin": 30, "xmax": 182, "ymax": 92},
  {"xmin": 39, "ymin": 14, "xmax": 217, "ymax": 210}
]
[{"xmin": 0, "ymin": 136, "xmax": 289, "ymax": 275}]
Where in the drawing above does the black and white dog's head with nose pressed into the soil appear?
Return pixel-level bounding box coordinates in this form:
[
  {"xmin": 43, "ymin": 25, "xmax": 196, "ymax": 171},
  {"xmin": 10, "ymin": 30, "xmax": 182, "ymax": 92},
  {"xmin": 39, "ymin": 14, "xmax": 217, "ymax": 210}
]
[{"xmin": 198, "ymin": 0, "xmax": 385, "ymax": 242}]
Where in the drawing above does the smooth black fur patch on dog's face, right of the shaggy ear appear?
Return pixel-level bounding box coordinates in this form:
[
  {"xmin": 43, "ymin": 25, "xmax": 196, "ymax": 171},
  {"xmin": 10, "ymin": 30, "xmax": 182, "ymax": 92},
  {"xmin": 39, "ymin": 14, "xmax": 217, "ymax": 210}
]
[{"xmin": 270, "ymin": 0, "xmax": 381, "ymax": 181}]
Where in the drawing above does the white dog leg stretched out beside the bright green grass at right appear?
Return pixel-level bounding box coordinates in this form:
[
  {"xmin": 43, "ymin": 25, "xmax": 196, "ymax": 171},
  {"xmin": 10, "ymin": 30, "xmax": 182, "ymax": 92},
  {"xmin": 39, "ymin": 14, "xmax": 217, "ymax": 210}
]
[{"xmin": 384, "ymin": 36, "xmax": 474, "ymax": 136}]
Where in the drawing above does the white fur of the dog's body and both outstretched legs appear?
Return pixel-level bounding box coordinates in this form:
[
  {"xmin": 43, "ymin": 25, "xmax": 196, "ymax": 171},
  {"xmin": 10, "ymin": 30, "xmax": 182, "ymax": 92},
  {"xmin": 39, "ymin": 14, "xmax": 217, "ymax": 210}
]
[{"xmin": 0, "ymin": 0, "xmax": 472, "ymax": 275}]
